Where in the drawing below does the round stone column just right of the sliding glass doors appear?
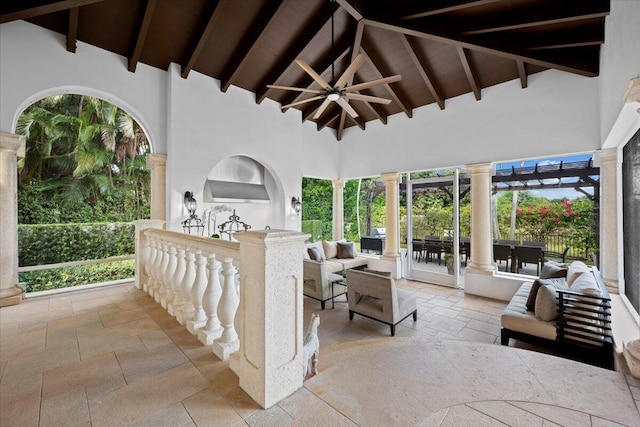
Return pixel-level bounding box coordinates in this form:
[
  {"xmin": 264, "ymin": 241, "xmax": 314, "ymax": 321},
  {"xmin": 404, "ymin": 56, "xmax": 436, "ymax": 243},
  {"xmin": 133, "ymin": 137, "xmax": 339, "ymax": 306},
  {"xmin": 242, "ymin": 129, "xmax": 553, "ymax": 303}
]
[{"xmin": 466, "ymin": 163, "xmax": 496, "ymax": 275}]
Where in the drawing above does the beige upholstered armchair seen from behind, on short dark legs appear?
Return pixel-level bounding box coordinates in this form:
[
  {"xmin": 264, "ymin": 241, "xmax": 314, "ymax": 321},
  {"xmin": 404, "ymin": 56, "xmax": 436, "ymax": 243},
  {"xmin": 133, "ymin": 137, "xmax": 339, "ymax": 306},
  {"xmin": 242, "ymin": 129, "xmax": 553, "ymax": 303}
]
[{"xmin": 347, "ymin": 270, "xmax": 418, "ymax": 336}]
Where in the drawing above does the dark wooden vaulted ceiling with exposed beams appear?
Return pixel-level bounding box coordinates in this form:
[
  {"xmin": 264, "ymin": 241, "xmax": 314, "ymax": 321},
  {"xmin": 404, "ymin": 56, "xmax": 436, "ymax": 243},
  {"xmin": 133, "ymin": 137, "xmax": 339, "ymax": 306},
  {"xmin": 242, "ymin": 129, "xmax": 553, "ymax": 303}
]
[{"xmin": 0, "ymin": 0, "xmax": 610, "ymax": 140}]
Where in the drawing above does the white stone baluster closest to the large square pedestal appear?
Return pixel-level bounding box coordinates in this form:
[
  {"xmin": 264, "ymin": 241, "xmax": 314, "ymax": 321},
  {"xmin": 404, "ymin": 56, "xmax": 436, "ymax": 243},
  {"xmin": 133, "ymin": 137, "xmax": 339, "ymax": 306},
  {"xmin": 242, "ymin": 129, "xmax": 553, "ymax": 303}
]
[{"xmin": 213, "ymin": 258, "xmax": 240, "ymax": 360}]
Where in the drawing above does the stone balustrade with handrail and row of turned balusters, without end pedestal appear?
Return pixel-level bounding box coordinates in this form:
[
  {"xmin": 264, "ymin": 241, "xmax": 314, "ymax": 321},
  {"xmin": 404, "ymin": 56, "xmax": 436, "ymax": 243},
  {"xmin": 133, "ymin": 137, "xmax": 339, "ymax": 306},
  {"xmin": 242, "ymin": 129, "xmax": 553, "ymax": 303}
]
[{"xmin": 136, "ymin": 221, "xmax": 240, "ymax": 360}]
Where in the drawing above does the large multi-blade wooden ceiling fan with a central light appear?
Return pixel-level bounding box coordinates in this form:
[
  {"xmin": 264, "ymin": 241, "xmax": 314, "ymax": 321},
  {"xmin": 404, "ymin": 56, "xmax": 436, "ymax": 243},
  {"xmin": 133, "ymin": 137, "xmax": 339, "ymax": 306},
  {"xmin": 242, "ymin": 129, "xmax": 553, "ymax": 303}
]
[{"xmin": 267, "ymin": 5, "xmax": 401, "ymax": 120}]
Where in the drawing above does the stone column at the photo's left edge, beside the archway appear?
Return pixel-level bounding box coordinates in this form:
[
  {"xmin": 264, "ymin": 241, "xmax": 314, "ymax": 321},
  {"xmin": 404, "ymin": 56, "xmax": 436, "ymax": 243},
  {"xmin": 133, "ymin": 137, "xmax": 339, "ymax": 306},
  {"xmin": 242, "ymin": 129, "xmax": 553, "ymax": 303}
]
[{"xmin": 0, "ymin": 133, "xmax": 25, "ymax": 307}]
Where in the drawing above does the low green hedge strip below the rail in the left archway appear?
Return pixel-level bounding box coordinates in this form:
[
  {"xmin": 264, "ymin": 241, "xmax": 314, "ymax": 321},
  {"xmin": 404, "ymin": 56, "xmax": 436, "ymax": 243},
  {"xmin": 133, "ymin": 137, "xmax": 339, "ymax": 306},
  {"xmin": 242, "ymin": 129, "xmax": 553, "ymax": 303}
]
[{"xmin": 19, "ymin": 260, "xmax": 135, "ymax": 292}]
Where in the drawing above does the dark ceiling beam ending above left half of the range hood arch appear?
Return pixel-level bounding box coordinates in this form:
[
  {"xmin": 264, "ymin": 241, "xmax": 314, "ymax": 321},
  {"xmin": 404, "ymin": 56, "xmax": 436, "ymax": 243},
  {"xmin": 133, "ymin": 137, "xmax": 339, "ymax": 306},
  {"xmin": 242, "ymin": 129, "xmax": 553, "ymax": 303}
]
[{"xmin": 220, "ymin": 0, "xmax": 284, "ymax": 92}]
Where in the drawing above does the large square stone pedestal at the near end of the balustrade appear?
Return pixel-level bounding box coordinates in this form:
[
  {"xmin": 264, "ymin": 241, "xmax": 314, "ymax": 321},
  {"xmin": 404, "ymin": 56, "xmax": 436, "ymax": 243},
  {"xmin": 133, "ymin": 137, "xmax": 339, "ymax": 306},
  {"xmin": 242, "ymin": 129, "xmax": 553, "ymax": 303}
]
[{"xmin": 235, "ymin": 230, "xmax": 309, "ymax": 408}]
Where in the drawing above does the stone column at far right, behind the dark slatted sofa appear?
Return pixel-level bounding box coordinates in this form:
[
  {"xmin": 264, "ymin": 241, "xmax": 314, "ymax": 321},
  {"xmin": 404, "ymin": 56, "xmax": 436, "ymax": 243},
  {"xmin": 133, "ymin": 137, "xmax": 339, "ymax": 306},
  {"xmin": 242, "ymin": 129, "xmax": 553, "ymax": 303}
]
[{"xmin": 595, "ymin": 148, "xmax": 620, "ymax": 294}]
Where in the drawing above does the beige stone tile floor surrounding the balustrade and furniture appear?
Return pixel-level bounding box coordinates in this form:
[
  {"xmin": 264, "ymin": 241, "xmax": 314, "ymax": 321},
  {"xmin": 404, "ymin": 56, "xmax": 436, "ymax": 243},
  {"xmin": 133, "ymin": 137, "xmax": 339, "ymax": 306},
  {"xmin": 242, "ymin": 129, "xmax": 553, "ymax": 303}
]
[{"xmin": 0, "ymin": 280, "xmax": 640, "ymax": 426}]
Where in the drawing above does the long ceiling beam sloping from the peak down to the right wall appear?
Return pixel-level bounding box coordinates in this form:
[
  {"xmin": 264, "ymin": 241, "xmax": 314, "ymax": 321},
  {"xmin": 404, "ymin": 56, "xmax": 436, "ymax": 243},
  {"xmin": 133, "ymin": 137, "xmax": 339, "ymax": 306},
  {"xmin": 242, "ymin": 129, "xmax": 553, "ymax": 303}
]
[{"xmin": 364, "ymin": 18, "xmax": 599, "ymax": 77}]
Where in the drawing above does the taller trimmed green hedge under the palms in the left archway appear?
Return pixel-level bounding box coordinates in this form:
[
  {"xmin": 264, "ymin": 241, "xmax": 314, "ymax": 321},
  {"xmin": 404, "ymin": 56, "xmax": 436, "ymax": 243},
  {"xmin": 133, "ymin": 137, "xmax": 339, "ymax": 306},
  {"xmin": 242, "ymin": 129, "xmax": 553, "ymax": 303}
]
[{"xmin": 18, "ymin": 222, "xmax": 135, "ymax": 267}]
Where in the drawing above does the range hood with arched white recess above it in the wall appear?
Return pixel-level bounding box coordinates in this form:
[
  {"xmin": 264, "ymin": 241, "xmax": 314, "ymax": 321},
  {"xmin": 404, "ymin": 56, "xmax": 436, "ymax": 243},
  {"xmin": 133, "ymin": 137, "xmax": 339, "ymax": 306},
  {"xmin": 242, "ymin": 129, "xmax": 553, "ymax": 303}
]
[{"xmin": 203, "ymin": 156, "xmax": 270, "ymax": 203}]
